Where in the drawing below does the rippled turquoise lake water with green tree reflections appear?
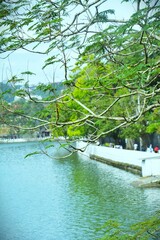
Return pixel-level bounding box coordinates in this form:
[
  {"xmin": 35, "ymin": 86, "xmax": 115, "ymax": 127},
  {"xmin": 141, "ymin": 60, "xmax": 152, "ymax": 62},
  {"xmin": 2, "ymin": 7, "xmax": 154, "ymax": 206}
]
[{"xmin": 0, "ymin": 143, "xmax": 160, "ymax": 240}]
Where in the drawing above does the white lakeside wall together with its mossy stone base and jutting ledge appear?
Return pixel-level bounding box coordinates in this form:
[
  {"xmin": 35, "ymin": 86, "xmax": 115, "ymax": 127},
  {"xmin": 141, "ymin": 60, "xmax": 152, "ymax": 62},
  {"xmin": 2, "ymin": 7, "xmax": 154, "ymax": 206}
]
[{"xmin": 76, "ymin": 141, "xmax": 160, "ymax": 188}]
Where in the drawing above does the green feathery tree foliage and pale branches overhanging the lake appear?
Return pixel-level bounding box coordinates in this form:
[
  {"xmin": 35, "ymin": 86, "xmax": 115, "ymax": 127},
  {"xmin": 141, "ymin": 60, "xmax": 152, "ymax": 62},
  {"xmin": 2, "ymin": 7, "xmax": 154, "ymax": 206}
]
[{"xmin": 0, "ymin": 0, "xmax": 160, "ymax": 141}]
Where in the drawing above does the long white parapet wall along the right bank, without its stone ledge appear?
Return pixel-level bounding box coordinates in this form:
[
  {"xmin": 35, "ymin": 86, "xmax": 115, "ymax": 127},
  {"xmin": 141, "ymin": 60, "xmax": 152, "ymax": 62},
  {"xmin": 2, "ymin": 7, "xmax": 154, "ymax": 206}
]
[{"xmin": 76, "ymin": 141, "xmax": 160, "ymax": 177}]
